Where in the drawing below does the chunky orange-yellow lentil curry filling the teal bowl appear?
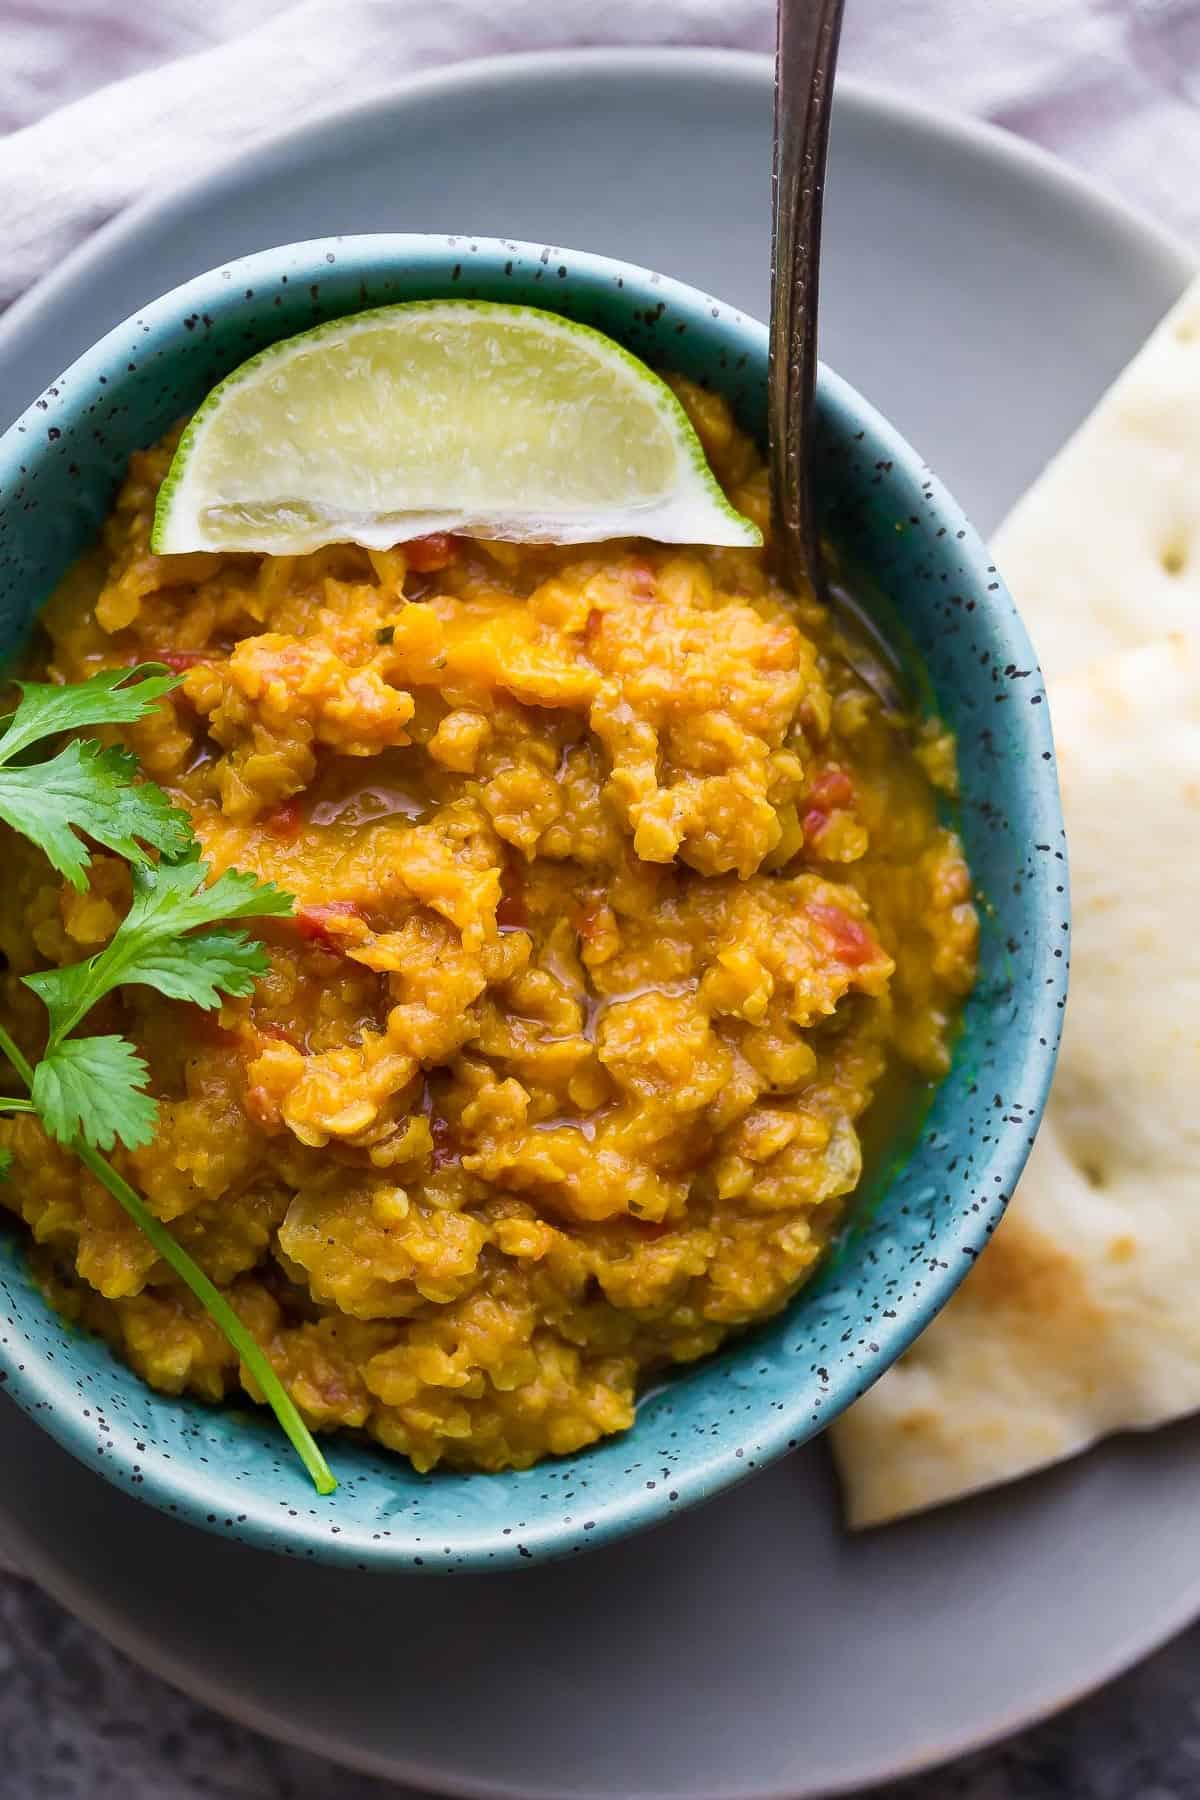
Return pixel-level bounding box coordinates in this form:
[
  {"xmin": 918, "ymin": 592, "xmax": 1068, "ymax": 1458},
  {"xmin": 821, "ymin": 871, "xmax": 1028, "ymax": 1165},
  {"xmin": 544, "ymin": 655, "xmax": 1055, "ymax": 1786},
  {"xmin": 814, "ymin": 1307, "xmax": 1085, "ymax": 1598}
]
[{"xmin": 0, "ymin": 383, "xmax": 977, "ymax": 1471}]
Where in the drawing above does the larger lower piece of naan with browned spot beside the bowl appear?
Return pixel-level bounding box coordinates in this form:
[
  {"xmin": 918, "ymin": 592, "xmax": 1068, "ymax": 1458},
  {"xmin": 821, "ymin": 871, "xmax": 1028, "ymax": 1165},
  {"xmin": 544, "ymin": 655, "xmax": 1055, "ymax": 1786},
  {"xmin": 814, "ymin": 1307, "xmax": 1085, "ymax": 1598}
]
[{"xmin": 833, "ymin": 637, "xmax": 1200, "ymax": 1526}]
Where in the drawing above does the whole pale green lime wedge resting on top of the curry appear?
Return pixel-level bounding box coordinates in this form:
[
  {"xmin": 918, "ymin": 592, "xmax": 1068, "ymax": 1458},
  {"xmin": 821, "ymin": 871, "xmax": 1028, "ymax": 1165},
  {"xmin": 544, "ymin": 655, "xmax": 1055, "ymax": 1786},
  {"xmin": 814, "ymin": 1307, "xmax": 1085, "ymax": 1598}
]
[{"xmin": 153, "ymin": 301, "xmax": 763, "ymax": 556}]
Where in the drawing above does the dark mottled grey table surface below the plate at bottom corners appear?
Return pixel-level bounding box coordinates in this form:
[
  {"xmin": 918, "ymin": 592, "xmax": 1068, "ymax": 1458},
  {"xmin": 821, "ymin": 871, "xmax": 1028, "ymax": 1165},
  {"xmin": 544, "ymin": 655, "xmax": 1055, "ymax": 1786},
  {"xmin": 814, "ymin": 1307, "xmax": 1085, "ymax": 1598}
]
[{"xmin": 0, "ymin": 1579, "xmax": 1200, "ymax": 1800}]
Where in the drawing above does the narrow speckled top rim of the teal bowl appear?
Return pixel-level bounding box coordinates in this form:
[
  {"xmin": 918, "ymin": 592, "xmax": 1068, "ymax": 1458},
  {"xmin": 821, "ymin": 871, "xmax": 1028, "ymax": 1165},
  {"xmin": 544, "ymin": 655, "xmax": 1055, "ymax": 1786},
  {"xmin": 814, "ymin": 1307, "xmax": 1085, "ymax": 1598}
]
[{"xmin": 0, "ymin": 232, "xmax": 1067, "ymax": 1573}]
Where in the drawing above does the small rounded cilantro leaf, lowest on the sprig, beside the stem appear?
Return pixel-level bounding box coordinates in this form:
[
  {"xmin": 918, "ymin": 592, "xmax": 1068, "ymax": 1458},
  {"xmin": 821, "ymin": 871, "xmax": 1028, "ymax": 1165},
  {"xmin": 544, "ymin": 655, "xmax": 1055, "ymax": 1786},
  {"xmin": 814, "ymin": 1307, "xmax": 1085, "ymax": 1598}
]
[{"xmin": 32, "ymin": 1037, "xmax": 158, "ymax": 1150}]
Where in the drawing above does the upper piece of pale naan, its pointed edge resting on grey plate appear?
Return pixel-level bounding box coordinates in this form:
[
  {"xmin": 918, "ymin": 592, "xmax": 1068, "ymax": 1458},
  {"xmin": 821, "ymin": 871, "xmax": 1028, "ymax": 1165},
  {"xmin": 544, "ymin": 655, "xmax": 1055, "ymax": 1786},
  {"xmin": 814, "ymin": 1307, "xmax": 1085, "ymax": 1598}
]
[{"xmin": 991, "ymin": 279, "xmax": 1200, "ymax": 684}]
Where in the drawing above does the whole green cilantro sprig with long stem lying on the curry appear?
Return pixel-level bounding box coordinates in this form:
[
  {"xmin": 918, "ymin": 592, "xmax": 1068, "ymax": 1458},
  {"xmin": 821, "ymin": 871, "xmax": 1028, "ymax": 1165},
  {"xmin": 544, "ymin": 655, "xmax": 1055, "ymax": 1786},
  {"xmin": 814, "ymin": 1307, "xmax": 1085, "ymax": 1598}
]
[{"xmin": 0, "ymin": 662, "xmax": 336, "ymax": 1494}]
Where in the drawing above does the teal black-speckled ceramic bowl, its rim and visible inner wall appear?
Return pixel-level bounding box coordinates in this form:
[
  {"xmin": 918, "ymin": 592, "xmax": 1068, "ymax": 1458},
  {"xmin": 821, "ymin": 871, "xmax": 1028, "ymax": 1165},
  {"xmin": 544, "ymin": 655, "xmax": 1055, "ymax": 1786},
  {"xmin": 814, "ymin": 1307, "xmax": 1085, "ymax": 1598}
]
[{"xmin": 0, "ymin": 236, "xmax": 1069, "ymax": 1571}]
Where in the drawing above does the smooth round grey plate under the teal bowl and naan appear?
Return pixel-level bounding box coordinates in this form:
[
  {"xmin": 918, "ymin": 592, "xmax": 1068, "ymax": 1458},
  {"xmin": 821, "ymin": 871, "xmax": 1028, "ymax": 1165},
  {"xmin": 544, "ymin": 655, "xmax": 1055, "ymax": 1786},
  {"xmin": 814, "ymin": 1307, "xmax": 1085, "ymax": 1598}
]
[{"xmin": 0, "ymin": 52, "xmax": 1200, "ymax": 1800}]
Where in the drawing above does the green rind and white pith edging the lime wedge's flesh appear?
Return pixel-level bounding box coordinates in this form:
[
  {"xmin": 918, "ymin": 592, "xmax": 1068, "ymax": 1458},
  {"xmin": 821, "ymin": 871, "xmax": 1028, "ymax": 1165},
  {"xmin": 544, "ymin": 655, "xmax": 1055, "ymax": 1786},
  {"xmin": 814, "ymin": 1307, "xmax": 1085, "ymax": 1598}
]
[{"xmin": 151, "ymin": 301, "xmax": 763, "ymax": 554}]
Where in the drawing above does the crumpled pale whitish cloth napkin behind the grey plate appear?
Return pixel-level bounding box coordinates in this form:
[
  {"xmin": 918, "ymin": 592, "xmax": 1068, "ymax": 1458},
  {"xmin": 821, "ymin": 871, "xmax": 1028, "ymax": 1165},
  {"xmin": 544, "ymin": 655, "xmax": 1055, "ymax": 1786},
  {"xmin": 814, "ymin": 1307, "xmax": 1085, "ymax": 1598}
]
[{"xmin": 0, "ymin": 0, "xmax": 1200, "ymax": 316}]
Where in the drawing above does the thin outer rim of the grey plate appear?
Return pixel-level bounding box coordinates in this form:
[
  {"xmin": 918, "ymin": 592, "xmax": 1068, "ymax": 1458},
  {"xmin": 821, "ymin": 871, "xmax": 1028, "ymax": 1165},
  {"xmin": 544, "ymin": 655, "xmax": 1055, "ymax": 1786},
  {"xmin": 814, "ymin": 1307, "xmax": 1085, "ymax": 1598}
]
[{"xmin": 0, "ymin": 47, "xmax": 1200, "ymax": 1800}]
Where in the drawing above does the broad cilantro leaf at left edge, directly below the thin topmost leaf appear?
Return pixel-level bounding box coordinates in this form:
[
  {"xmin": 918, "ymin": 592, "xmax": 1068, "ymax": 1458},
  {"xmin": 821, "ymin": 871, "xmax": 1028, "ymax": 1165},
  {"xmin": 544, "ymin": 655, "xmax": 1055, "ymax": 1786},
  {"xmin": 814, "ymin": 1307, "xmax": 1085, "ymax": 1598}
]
[{"xmin": 0, "ymin": 738, "xmax": 191, "ymax": 887}]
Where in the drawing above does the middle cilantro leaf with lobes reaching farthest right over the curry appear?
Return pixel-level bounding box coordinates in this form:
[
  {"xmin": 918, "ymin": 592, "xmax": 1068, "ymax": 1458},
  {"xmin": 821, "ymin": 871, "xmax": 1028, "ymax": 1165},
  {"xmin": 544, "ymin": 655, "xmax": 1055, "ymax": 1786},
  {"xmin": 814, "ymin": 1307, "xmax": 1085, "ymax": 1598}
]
[{"xmin": 23, "ymin": 859, "xmax": 293, "ymax": 1053}]
